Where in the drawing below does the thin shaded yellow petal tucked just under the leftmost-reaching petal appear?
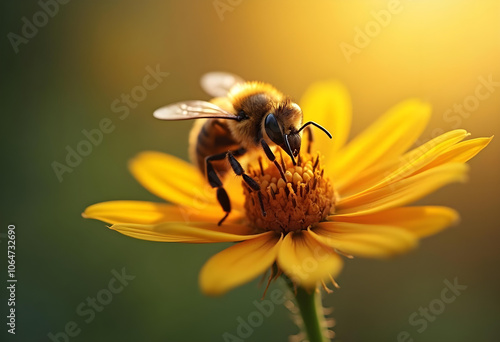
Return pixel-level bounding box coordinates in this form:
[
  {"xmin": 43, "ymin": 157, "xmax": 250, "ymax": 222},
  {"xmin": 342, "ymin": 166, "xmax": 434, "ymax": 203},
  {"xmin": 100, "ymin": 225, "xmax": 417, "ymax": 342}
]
[{"xmin": 110, "ymin": 222, "xmax": 259, "ymax": 243}]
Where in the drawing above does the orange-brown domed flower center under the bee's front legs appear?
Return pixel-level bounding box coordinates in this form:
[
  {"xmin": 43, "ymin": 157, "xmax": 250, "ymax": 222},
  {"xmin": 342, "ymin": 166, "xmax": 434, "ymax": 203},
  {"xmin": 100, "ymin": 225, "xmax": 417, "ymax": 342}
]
[{"xmin": 244, "ymin": 153, "xmax": 335, "ymax": 233}]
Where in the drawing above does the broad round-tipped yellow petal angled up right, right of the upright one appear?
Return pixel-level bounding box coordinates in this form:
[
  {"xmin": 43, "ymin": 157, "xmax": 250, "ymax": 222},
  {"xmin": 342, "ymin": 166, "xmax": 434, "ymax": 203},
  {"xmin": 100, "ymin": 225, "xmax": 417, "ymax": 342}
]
[{"xmin": 327, "ymin": 99, "xmax": 431, "ymax": 187}]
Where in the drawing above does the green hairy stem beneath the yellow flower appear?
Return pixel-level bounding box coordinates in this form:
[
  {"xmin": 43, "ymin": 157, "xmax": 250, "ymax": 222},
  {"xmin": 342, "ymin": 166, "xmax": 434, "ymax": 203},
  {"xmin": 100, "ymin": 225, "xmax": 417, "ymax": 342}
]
[{"xmin": 286, "ymin": 279, "xmax": 330, "ymax": 342}]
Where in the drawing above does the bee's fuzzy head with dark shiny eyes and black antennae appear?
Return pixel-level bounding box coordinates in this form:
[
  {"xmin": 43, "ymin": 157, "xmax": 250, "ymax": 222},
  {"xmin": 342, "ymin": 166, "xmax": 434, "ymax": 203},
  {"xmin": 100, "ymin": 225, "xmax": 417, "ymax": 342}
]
[{"xmin": 264, "ymin": 102, "xmax": 332, "ymax": 165}]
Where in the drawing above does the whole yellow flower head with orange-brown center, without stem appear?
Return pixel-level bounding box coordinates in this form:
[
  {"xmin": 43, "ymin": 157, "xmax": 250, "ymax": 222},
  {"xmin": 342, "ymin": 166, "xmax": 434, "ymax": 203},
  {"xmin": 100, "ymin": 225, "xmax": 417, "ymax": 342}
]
[{"xmin": 83, "ymin": 82, "xmax": 492, "ymax": 295}]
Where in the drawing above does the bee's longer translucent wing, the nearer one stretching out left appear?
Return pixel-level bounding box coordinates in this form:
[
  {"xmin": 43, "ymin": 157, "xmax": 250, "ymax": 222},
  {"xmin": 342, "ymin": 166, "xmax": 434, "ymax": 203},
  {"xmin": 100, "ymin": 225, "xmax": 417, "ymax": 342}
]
[{"xmin": 153, "ymin": 101, "xmax": 239, "ymax": 120}]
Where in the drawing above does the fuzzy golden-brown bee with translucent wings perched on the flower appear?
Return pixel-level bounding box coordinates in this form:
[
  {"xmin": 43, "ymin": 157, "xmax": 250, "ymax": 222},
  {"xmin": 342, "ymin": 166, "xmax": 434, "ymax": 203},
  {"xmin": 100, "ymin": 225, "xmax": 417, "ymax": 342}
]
[{"xmin": 153, "ymin": 72, "xmax": 332, "ymax": 225}]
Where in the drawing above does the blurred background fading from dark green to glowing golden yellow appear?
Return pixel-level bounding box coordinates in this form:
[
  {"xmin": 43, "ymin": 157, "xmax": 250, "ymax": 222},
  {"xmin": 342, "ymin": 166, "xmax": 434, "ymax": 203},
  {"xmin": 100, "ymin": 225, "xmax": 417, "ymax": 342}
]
[{"xmin": 0, "ymin": 0, "xmax": 500, "ymax": 342}]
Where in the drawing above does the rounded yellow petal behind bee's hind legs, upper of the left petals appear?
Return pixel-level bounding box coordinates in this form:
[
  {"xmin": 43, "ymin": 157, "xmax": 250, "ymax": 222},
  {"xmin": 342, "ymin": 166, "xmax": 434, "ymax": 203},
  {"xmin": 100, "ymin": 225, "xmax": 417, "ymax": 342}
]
[{"xmin": 129, "ymin": 151, "xmax": 220, "ymax": 211}]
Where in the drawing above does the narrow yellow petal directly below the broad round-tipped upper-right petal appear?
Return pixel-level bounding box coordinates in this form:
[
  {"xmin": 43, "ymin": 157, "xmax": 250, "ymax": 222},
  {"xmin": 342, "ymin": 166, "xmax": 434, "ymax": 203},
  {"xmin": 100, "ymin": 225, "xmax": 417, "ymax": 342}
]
[{"xmin": 336, "ymin": 130, "xmax": 468, "ymax": 197}]
